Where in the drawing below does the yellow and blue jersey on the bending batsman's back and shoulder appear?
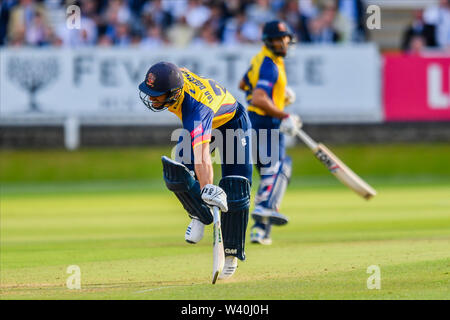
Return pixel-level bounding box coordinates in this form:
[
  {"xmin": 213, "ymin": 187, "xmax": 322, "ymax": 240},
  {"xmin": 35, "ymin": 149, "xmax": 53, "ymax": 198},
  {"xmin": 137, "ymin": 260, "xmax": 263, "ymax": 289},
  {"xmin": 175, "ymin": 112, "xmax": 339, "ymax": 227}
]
[{"xmin": 168, "ymin": 68, "xmax": 238, "ymax": 148}]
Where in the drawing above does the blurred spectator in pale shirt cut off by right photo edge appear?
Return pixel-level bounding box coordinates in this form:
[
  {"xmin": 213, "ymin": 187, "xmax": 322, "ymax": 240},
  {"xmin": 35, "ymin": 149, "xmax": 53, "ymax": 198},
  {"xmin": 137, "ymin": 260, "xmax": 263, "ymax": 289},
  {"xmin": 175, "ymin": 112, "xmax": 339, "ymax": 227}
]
[{"xmin": 424, "ymin": 0, "xmax": 450, "ymax": 49}]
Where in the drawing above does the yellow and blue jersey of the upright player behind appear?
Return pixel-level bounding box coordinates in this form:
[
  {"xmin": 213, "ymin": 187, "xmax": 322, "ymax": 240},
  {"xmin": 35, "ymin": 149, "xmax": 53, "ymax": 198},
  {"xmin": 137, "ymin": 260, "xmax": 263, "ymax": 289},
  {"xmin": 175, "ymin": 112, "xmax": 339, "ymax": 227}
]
[{"xmin": 243, "ymin": 46, "xmax": 287, "ymax": 116}]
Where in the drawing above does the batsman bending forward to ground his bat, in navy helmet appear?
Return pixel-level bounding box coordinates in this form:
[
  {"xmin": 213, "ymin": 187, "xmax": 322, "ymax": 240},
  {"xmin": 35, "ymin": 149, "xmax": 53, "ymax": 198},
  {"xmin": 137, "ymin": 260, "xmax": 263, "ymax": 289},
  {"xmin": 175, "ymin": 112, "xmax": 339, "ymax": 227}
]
[{"xmin": 139, "ymin": 62, "xmax": 252, "ymax": 280}]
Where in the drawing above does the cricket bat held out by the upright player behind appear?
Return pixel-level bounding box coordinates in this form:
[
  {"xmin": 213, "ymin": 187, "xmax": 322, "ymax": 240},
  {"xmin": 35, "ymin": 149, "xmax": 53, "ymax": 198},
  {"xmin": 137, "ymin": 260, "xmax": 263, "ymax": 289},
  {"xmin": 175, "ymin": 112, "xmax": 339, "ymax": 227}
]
[{"xmin": 297, "ymin": 129, "xmax": 377, "ymax": 200}]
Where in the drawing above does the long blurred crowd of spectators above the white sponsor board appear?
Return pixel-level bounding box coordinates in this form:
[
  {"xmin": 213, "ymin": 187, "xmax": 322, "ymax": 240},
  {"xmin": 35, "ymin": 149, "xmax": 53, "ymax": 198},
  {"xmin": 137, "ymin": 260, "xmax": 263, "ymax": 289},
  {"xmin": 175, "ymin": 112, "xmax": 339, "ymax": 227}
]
[{"xmin": 0, "ymin": 0, "xmax": 366, "ymax": 48}]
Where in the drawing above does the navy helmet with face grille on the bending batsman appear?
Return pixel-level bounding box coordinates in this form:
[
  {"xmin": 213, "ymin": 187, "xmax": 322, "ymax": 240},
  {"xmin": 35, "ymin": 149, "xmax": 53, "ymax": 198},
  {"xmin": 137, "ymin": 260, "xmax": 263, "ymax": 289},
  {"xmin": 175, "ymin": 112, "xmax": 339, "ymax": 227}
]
[{"xmin": 139, "ymin": 62, "xmax": 184, "ymax": 111}]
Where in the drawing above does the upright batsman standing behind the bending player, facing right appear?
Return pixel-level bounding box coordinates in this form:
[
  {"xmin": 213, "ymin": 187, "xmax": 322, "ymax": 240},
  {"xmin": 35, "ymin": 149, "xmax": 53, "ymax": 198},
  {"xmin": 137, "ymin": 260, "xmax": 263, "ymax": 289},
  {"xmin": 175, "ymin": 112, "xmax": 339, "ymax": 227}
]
[{"xmin": 239, "ymin": 20, "xmax": 301, "ymax": 245}]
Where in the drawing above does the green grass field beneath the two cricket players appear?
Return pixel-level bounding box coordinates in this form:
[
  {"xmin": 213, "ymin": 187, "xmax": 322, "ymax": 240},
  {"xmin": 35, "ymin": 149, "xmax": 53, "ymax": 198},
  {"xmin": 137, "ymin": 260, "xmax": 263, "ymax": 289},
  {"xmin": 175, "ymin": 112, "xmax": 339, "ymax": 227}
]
[{"xmin": 0, "ymin": 144, "xmax": 450, "ymax": 299}]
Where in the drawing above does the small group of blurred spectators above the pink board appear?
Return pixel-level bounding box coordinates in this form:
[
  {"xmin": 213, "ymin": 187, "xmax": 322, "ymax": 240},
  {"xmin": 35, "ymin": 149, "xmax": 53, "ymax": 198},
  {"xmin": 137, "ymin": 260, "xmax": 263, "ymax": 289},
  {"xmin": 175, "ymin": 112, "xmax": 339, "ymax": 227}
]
[{"xmin": 402, "ymin": 0, "xmax": 450, "ymax": 54}]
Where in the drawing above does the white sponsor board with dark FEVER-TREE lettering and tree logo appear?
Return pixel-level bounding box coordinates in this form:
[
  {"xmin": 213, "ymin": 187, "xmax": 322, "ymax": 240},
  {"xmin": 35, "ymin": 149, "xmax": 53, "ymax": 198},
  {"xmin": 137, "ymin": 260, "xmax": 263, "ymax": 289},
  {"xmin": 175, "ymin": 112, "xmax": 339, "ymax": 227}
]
[{"xmin": 0, "ymin": 45, "xmax": 382, "ymax": 124}]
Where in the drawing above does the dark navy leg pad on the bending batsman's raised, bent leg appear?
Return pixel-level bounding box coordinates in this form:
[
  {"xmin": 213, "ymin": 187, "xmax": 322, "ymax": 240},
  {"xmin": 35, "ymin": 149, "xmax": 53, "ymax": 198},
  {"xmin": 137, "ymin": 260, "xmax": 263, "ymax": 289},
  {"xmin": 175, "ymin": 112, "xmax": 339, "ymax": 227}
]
[{"xmin": 161, "ymin": 156, "xmax": 213, "ymax": 224}]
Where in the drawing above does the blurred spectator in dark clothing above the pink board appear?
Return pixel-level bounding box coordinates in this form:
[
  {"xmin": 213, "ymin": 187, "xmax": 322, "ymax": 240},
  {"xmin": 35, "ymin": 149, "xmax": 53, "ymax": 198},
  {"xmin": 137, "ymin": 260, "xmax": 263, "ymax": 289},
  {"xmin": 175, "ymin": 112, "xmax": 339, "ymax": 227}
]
[{"xmin": 402, "ymin": 10, "xmax": 437, "ymax": 51}]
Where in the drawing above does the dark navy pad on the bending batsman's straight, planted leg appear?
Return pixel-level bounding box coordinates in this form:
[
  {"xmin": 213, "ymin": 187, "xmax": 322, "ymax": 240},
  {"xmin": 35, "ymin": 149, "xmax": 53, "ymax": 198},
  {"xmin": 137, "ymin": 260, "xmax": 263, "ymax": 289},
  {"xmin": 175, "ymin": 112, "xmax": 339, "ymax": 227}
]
[{"xmin": 219, "ymin": 176, "xmax": 250, "ymax": 260}]
